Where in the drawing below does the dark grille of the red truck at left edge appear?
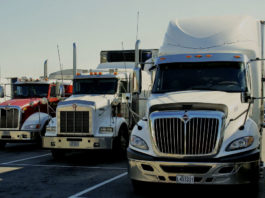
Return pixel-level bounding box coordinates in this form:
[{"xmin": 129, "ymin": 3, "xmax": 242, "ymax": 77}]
[{"xmin": 0, "ymin": 108, "xmax": 19, "ymax": 129}]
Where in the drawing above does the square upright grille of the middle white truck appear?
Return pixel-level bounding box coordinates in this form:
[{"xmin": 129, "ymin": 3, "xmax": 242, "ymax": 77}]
[{"xmin": 60, "ymin": 111, "xmax": 89, "ymax": 133}]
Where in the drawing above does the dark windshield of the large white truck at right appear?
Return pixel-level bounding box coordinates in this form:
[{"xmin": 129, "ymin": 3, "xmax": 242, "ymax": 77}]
[{"xmin": 152, "ymin": 62, "xmax": 246, "ymax": 93}]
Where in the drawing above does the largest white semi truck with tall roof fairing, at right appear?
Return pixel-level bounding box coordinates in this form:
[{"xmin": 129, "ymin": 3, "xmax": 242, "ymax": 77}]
[{"xmin": 127, "ymin": 16, "xmax": 264, "ymax": 189}]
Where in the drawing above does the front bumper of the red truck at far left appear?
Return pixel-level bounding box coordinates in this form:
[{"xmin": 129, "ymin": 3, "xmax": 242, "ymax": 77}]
[{"xmin": 0, "ymin": 131, "xmax": 40, "ymax": 142}]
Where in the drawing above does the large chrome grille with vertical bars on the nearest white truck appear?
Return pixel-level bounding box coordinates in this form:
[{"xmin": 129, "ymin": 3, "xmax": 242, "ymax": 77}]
[{"xmin": 154, "ymin": 117, "xmax": 219, "ymax": 155}]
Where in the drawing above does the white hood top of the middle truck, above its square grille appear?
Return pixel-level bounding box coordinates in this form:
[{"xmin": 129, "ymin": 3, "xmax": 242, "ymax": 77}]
[{"xmin": 59, "ymin": 94, "xmax": 115, "ymax": 109}]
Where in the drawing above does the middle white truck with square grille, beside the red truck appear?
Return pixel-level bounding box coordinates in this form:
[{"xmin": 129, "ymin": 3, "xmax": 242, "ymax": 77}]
[{"xmin": 43, "ymin": 42, "xmax": 158, "ymax": 158}]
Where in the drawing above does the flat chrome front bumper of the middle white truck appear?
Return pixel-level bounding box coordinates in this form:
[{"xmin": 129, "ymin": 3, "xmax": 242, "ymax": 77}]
[{"xmin": 42, "ymin": 137, "xmax": 113, "ymax": 150}]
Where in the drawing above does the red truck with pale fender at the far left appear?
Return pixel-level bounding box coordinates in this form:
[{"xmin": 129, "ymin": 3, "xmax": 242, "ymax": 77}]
[{"xmin": 0, "ymin": 78, "xmax": 72, "ymax": 148}]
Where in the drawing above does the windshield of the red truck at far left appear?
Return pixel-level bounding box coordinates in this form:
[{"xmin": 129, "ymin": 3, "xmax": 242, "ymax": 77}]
[{"xmin": 14, "ymin": 84, "xmax": 49, "ymax": 98}]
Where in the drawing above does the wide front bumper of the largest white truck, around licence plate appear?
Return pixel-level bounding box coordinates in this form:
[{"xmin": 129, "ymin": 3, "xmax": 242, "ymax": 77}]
[{"xmin": 128, "ymin": 149, "xmax": 260, "ymax": 185}]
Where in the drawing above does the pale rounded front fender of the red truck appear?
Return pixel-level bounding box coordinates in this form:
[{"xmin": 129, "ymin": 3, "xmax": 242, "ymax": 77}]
[{"xmin": 21, "ymin": 112, "xmax": 51, "ymax": 131}]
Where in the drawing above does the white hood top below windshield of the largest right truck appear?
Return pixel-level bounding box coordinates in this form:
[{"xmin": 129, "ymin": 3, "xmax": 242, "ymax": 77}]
[{"xmin": 148, "ymin": 91, "xmax": 248, "ymax": 119}]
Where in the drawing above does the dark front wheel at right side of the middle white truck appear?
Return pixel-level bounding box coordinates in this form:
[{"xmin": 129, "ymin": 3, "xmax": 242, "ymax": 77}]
[{"xmin": 112, "ymin": 127, "xmax": 129, "ymax": 159}]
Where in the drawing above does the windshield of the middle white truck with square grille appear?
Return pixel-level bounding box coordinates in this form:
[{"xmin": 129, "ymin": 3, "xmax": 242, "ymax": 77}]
[{"xmin": 74, "ymin": 78, "xmax": 118, "ymax": 94}]
